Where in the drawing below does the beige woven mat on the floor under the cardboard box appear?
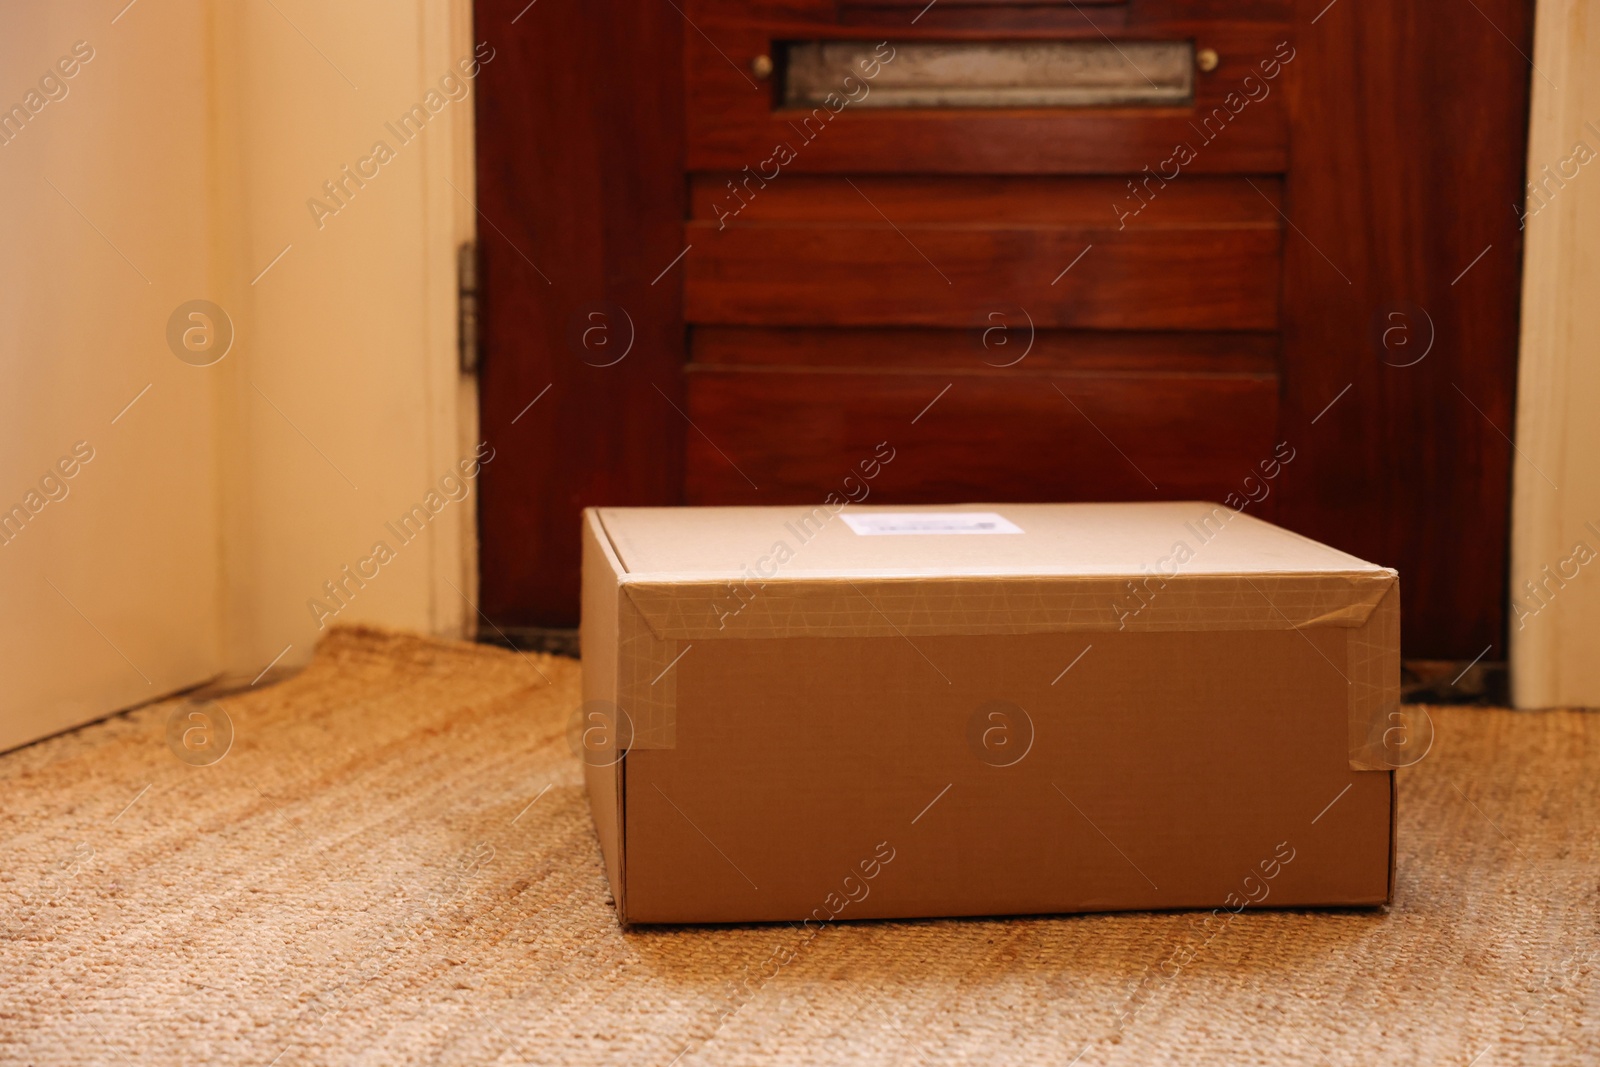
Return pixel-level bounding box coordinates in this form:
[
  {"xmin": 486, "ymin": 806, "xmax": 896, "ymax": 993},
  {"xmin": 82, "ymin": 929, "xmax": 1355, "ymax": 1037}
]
[{"xmin": 0, "ymin": 630, "xmax": 1600, "ymax": 1067}]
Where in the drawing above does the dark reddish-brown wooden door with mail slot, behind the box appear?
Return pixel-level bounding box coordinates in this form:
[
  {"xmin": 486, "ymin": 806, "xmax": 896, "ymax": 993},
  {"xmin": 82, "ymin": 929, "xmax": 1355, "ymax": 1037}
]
[{"xmin": 477, "ymin": 0, "xmax": 1531, "ymax": 657}]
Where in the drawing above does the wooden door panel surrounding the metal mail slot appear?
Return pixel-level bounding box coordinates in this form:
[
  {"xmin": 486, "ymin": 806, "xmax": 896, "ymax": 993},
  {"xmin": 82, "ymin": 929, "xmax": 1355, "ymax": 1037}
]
[{"xmin": 685, "ymin": 0, "xmax": 1293, "ymax": 174}]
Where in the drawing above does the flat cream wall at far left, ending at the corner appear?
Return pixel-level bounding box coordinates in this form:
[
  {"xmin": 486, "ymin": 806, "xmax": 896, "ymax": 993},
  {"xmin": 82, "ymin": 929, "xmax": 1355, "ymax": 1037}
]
[{"xmin": 0, "ymin": 0, "xmax": 222, "ymax": 749}]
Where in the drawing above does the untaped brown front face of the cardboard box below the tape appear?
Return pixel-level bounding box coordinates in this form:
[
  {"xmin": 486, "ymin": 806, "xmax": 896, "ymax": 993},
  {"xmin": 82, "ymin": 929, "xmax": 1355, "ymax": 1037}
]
[{"xmin": 626, "ymin": 627, "xmax": 1394, "ymax": 921}]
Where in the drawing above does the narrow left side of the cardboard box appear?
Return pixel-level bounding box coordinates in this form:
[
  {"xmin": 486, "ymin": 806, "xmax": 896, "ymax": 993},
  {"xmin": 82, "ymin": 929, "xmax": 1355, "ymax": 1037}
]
[{"xmin": 570, "ymin": 509, "xmax": 627, "ymax": 921}]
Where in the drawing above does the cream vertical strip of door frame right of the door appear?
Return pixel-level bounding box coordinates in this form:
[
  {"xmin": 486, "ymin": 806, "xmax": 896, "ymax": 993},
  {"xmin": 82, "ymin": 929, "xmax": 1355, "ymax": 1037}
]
[{"xmin": 1510, "ymin": 0, "xmax": 1600, "ymax": 707}]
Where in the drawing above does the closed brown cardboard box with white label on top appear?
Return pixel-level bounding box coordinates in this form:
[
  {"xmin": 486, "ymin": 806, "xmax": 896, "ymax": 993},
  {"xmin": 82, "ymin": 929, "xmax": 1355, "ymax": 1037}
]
[{"xmin": 571, "ymin": 502, "xmax": 1400, "ymax": 923}]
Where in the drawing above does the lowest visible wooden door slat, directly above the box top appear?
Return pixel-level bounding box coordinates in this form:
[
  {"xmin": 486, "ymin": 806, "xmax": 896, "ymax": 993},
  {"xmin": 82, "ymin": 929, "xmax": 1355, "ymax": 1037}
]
[{"xmin": 686, "ymin": 366, "xmax": 1277, "ymax": 504}]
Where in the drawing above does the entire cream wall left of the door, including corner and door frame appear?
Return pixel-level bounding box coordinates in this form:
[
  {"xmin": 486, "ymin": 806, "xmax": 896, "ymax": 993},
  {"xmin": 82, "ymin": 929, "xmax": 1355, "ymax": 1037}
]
[{"xmin": 0, "ymin": 0, "xmax": 477, "ymax": 749}]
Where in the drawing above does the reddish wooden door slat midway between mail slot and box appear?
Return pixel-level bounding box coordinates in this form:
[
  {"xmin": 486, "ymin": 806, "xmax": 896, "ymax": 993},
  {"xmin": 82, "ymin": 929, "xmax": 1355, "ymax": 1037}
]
[{"xmin": 683, "ymin": 222, "xmax": 1282, "ymax": 330}]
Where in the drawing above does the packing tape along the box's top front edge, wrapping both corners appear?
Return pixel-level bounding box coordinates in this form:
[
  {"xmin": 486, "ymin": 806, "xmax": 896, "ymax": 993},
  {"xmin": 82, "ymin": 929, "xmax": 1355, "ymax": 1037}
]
[{"xmin": 618, "ymin": 571, "xmax": 1400, "ymax": 771}]
